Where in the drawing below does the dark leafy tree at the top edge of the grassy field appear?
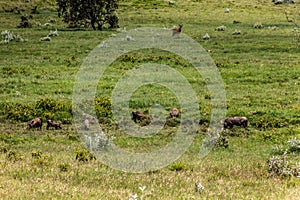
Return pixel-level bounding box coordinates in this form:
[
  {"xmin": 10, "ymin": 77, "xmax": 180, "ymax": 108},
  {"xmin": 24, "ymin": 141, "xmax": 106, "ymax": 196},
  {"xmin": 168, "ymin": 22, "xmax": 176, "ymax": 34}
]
[{"xmin": 56, "ymin": 0, "xmax": 119, "ymax": 30}]
